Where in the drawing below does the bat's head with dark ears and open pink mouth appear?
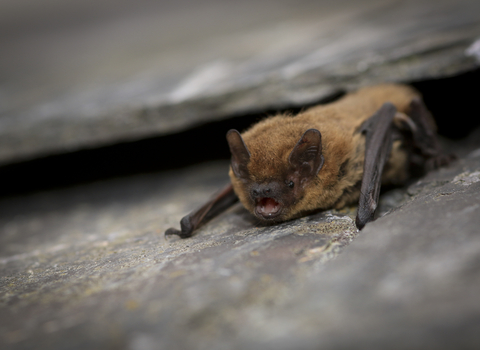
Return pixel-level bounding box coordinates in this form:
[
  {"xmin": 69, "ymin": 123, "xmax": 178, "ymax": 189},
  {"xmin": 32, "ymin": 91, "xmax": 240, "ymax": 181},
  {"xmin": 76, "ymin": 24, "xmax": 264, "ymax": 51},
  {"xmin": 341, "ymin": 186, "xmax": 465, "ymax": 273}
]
[{"xmin": 227, "ymin": 129, "xmax": 324, "ymax": 222}]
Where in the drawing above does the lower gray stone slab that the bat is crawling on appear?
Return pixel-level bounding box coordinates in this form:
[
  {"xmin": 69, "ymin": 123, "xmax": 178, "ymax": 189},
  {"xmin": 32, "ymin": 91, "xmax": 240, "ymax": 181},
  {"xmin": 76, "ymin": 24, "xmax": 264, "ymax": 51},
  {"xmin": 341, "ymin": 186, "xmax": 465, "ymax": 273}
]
[{"xmin": 0, "ymin": 130, "xmax": 480, "ymax": 350}]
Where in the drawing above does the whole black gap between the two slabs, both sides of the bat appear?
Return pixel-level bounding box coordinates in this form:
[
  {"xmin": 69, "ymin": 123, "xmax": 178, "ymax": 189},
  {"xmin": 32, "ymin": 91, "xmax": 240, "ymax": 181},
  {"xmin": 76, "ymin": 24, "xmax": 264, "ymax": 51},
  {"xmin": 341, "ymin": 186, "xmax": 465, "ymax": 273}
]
[{"xmin": 0, "ymin": 70, "xmax": 480, "ymax": 196}]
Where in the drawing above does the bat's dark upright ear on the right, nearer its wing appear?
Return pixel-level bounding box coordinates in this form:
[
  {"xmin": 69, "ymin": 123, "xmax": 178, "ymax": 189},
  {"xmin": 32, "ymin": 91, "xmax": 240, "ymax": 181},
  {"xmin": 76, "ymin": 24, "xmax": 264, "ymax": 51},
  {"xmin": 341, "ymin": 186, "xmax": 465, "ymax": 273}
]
[{"xmin": 288, "ymin": 129, "xmax": 324, "ymax": 182}]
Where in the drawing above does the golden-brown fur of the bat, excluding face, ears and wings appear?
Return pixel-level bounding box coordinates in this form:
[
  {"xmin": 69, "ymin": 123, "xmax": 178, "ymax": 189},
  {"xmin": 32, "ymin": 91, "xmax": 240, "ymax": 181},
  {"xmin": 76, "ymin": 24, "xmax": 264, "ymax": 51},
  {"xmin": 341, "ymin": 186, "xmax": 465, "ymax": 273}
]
[{"xmin": 229, "ymin": 84, "xmax": 419, "ymax": 220}]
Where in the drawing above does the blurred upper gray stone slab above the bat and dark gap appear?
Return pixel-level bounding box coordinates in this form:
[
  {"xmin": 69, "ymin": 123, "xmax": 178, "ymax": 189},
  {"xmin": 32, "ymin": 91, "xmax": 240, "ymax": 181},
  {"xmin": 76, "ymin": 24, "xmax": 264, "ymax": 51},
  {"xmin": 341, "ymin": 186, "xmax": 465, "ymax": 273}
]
[{"xmin": 0, "ymin": 0, "xmax": 480, "ymax": 164}]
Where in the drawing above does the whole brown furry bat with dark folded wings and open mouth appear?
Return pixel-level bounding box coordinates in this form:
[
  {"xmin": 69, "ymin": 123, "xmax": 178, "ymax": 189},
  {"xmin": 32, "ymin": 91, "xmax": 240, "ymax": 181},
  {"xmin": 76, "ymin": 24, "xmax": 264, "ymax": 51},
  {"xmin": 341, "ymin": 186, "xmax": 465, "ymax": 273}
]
[{"xmin": 165, "ymin": 84, "xmax": 454, "ymax": 238}]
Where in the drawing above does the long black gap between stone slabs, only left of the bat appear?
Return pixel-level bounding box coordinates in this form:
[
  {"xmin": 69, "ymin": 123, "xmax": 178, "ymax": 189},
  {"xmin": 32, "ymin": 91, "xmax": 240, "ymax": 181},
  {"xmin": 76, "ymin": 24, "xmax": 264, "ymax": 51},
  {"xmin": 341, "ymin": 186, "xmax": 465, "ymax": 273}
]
[{"xmin": 0, "ymin": 92, "xmax": 343, "ymax": 196}]
